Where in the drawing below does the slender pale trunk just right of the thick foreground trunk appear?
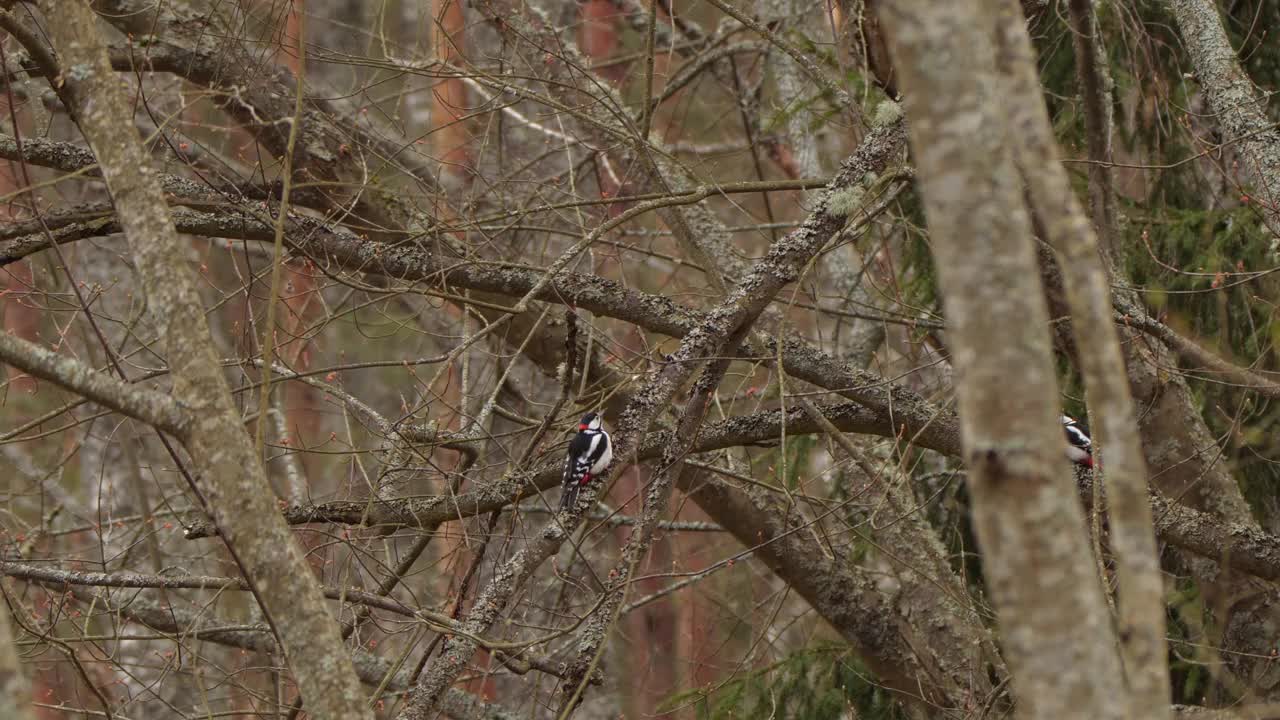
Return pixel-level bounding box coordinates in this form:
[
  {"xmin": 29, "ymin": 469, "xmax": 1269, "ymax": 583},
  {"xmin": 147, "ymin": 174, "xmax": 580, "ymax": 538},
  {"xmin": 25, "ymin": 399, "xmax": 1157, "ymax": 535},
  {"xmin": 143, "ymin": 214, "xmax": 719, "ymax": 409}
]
[{"xmin": 997, "ymin": 0, "xmax": 1170, "ymax": 719}]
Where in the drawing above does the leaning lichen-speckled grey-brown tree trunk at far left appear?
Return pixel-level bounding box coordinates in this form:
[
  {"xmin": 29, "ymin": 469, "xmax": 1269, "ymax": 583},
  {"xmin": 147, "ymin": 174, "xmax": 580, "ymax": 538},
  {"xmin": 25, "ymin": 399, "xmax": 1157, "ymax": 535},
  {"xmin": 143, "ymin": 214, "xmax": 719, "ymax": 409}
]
[{"xmin": 31, "ymin": 0, "xmax": 371, "ymax": 717}]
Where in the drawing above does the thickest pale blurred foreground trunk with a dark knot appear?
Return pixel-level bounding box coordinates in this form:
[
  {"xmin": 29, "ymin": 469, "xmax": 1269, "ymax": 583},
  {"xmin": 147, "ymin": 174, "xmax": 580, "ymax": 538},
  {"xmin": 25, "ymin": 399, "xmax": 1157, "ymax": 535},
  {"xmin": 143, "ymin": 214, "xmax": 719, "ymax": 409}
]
[{"xmin": 881, "ymin": 0, "xmax": 1129, "ymax": 720}]
